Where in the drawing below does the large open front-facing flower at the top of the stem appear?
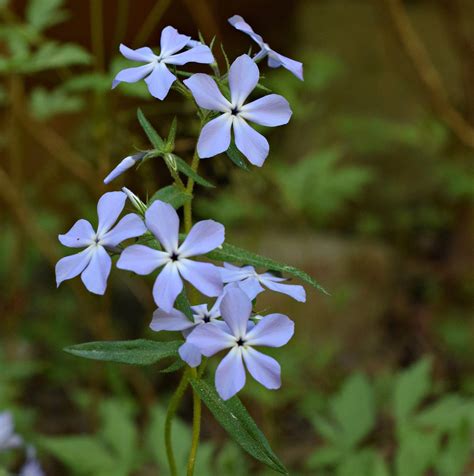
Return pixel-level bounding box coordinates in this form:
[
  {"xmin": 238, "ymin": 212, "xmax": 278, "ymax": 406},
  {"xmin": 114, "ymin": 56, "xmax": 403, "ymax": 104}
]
[{"xmin": 184, "ymin": 55, "xmax": 292, "ymax": 167}]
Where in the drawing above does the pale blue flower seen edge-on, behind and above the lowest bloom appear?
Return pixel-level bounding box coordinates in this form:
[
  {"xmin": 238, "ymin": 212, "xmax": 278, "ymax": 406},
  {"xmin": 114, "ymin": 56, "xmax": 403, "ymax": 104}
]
[{"xmin": 221, "ymin": 263, "xmax": 306, "ymax": 302}]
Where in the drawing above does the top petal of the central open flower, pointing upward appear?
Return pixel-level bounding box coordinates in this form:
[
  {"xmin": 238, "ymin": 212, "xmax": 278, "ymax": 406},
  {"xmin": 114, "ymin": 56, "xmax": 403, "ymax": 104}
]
[{"xmin": 145, "ymin": 200, "xmax": 179, "ymax": 253}]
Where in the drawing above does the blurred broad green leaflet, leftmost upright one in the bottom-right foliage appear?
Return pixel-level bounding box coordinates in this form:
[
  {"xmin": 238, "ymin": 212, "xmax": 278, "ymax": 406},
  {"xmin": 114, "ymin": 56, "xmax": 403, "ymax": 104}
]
[{"xmin": 331, "ymin": 374, "xmax": 375, "ymax": 448}]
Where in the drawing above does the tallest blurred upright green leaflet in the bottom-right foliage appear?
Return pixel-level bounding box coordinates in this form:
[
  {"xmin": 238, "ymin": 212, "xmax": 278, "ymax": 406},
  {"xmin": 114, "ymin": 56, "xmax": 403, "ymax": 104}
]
[{"xmin": 393, "ymin": 358, "xmax": 431, "ymax": 423}]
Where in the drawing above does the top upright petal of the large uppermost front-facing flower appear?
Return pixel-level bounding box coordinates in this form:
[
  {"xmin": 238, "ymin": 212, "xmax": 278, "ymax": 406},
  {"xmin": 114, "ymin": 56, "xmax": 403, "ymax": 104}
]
[{"xmin": 229, "ymin": 55, "xmax": 260, "ymax": 108}]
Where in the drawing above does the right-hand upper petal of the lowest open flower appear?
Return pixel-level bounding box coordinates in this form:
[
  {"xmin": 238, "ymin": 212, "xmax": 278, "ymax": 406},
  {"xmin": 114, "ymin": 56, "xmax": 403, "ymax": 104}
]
[{"xmin": 245, "ymin": 314, "xmax": 295, "ymax": 347}]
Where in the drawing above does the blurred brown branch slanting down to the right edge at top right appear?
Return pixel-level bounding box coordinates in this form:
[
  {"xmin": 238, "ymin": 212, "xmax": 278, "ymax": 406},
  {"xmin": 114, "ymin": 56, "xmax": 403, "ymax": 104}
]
[{"xmin": 384, "ymin": 0, "xmax": 474, "ymax": 148}]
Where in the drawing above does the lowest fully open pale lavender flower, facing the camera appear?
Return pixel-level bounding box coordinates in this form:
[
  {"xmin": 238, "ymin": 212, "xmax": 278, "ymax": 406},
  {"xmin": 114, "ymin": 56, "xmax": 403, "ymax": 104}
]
[{"xmin": 186, "ymin": 288, "xmax": 294, "ymax": 400}]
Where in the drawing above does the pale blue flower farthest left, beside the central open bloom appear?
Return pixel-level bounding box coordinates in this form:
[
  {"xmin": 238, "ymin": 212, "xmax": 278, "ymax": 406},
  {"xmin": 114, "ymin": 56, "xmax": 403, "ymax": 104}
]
[{"xmin": 56, "ymin": 192, "xmax": 146, "ymax": 294}]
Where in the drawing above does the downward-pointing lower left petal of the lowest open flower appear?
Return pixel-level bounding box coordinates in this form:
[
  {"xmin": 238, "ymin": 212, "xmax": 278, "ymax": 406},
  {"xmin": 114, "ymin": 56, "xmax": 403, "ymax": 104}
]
[{"xmin": 216, "ymin": 347, "xmax": 245, "ymax": 400}]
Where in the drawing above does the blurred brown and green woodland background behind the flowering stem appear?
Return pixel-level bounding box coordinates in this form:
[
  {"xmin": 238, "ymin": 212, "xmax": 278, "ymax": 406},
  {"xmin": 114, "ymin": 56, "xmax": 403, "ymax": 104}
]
[{"xmin": 0, "ymin": 0, "xmax": 474, "ymax": 476}]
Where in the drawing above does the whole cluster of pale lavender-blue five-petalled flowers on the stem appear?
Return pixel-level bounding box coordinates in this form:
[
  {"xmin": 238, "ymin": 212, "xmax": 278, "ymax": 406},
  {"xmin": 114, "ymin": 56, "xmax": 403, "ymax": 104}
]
[{"xmin": 56, "ymin": 15, "xmax": 306, "ymax": 402}]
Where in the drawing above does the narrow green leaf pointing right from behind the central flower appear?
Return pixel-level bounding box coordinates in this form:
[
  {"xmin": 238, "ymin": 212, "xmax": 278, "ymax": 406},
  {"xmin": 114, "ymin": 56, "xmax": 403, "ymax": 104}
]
[{"xmin": 206, "ymin": 243, "xmax": 329, "ymax": 294}]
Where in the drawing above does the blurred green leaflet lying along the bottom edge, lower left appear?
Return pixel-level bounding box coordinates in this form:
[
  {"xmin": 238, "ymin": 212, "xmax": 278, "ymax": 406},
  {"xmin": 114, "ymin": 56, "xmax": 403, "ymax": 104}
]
[{"xmin": 38, "ymin": 436, "xmax": 117, "ymax": 474}]
